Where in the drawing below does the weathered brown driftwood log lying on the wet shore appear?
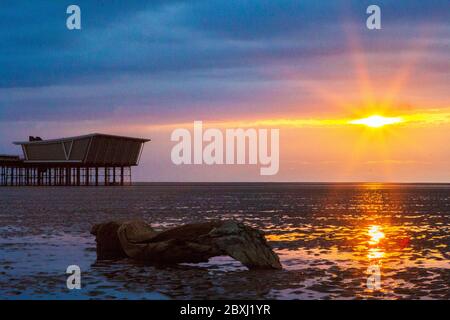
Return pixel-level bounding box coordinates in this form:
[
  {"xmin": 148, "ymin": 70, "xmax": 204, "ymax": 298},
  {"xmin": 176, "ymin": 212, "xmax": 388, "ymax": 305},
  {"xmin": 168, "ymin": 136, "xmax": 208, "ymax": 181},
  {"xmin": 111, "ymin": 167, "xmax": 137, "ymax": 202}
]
[{"xmin": 91, "ymin": 220, "xmax": 281, "ymax": 269}]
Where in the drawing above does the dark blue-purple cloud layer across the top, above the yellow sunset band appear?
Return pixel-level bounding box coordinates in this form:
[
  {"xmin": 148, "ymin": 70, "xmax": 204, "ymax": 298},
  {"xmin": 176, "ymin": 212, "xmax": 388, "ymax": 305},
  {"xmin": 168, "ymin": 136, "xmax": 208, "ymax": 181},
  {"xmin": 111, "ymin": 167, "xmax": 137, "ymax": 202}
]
[{"xmin": 0, "ymin": 0, "xmax": 450, "ymax": 121}]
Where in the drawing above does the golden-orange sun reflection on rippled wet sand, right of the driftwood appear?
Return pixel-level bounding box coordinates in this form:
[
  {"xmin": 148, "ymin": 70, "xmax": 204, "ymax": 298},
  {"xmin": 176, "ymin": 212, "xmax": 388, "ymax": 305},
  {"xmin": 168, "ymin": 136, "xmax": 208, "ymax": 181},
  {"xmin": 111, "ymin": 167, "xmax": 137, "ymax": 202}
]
[{"xmin": 267, "ymin": 220, "xmax": 450, "ymax": 298}]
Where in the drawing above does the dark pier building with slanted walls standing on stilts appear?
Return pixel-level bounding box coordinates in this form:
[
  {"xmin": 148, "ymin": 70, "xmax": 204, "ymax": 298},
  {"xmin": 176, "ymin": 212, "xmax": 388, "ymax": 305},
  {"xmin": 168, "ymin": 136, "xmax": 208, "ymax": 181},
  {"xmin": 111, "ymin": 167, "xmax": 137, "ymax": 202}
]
[{"xmin": 0, "ymin": 133, "xmax": 150, "ymax": 186}]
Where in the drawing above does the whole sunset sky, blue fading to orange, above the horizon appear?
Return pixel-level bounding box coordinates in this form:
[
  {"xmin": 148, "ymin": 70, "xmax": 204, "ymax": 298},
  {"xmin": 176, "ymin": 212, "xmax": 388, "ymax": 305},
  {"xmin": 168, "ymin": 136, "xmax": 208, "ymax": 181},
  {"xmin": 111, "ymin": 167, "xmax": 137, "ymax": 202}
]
[{"xmin": 0, "ymin": 0, "xmax": 450, "ymax": 182}]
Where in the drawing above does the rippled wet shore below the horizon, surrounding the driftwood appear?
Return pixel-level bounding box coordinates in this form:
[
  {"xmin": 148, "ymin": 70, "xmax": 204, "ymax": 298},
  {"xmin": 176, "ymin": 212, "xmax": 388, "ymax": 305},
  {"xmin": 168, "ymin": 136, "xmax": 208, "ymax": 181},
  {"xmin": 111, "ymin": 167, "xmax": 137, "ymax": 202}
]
[{"xmin": 0, "ymin": 184, "xmax": 450, "ymax": 299}]
